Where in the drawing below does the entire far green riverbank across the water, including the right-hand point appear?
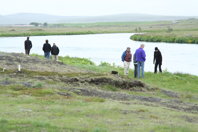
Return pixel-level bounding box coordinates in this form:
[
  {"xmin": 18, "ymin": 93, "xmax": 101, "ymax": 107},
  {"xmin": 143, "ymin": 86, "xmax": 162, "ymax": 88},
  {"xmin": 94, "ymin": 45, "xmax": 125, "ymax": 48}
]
[{"xmin": 0, "ymin": 19, "xmax": 198, "ymax": 41}]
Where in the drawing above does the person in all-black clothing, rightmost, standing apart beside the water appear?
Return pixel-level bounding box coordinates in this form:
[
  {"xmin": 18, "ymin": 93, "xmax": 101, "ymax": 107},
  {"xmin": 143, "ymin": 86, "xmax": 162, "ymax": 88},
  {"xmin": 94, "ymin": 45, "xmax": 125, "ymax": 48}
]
[{"xmin": 153, "ymin": 47, "xmax": 162, "ymax": 73}]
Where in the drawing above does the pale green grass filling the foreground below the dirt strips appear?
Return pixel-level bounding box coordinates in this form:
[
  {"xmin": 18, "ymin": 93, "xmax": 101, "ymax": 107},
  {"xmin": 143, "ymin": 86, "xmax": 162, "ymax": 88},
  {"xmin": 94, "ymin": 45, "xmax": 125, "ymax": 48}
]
[{"xmin": 0, "ymin": 88, "xmax": 197, "ymax": 132}]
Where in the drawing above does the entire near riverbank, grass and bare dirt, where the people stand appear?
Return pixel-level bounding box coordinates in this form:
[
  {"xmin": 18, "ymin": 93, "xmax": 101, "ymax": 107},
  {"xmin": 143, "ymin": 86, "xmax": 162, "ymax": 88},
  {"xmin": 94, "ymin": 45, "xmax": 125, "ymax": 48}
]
[{"xmin": 0, "ymin": 52, "xmax": 198, "ymax": 132}]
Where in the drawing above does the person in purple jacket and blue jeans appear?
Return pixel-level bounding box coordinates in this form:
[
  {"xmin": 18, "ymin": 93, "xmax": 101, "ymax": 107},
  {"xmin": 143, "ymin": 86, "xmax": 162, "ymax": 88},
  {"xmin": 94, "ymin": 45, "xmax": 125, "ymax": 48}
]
[{"xmin": 135, "ymin": 44, "xmax": 146, "ymax": 78}]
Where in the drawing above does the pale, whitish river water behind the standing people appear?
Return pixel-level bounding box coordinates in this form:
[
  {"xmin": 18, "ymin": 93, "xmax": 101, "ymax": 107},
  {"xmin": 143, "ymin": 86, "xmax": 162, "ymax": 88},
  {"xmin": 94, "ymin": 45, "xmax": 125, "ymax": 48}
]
[{"xmin": 0, "ymin": 33, "xmax": 198, "ymax": 75}]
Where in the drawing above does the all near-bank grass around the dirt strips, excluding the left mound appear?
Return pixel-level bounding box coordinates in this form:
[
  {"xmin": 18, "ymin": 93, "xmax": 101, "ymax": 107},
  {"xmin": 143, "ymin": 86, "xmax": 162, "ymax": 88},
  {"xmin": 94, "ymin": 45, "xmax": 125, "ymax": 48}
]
[{"xmin": 0, "ymin": 55, "xmax": 198, "ymax": 132}]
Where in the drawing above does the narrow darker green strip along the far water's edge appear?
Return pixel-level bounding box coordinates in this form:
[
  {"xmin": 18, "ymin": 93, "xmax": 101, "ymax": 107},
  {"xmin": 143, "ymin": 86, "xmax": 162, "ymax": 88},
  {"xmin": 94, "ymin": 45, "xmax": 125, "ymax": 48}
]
[{"xmin": 0, "ymin": 31, "xmax": 198, "ymax": 45}]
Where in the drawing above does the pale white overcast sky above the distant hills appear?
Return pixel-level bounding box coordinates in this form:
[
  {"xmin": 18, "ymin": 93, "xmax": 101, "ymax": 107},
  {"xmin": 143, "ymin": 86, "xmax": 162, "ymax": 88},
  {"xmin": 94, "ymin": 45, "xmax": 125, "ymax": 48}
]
[{"xmin": 0, "ymin": 0, "xmax": 198, "ymax": 16}]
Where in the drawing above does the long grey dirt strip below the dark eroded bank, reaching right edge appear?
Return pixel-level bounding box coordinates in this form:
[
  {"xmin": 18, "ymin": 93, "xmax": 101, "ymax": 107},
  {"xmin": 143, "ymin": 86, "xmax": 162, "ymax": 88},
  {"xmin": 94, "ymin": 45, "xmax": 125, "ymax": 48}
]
[{"xmin": 62, "ymin": 88, "xmax": 198, "ymax": 113}]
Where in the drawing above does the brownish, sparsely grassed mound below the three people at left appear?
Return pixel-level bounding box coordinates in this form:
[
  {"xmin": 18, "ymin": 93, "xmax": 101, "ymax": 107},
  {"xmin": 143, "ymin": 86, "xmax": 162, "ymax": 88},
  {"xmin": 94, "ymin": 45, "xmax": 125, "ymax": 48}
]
[{"xmin": 0, "ymin": 52, "xmax": 88, "ymax": 73}]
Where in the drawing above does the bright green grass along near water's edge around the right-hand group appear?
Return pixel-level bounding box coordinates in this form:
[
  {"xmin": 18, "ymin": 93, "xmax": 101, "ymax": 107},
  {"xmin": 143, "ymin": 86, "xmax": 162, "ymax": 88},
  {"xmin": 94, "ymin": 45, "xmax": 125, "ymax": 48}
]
[{"xmin": 31, "ymin": 55, "xmax": 198, "ymax": 94}]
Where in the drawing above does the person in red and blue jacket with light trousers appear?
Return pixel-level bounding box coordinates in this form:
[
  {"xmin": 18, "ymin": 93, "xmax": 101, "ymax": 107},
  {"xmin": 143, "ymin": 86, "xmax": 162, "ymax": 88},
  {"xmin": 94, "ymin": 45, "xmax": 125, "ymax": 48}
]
[{"xmin": 122, "ymin": 47, "xmax": 132, "ymax": 75}]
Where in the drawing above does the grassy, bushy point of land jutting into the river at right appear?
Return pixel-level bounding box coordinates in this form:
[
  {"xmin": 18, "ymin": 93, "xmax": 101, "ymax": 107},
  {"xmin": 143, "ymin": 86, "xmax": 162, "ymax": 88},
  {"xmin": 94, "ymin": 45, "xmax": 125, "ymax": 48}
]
[{"xmin": 131, "ymin": 19, "xmax": 198, "ymax": 44}]
